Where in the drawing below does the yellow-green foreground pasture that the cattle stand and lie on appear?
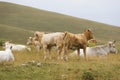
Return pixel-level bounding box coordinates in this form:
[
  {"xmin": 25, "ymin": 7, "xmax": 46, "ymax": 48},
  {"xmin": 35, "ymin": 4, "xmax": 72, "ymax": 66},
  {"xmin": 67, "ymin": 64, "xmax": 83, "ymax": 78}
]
[{"xmin": 0, "ymin": 46, "xmax": 120, "ymax": 80}]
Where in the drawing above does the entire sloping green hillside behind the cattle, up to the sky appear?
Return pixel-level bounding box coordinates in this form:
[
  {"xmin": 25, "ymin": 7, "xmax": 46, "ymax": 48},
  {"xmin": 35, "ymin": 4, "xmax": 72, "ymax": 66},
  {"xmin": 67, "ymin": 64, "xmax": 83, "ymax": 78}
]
[{"xmin": 0, "ymin": 2, "xmax": 120, "ymax": 43}]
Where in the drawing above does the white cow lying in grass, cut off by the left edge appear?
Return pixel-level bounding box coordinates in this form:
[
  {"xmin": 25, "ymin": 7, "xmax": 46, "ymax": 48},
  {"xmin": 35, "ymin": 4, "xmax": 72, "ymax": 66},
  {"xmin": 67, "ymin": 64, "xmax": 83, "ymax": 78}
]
[{"xmin": 0, "ymin": 44, "xmax": 14, "ymax": 63}]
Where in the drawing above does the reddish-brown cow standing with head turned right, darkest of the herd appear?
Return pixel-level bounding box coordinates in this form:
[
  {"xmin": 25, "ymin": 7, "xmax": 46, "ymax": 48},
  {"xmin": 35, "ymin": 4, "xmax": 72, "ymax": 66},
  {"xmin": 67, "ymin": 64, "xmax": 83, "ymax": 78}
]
[{"xmin": 64, "ymin": 29, "xmax": 93, "ymax": 60}]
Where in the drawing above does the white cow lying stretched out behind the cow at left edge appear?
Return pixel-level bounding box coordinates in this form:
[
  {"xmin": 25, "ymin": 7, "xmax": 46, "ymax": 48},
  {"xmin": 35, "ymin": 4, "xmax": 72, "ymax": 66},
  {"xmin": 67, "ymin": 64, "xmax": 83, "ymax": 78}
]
[{"xmin": 5, "ymin": 41, "xmax": 31, "ymax": 51}]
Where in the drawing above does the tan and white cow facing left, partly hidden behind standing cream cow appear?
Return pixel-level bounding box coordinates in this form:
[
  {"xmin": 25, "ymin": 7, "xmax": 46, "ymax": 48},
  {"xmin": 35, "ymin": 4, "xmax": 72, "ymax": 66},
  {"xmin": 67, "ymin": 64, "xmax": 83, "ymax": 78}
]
[{"xmin": 27, "ymin": 37, "xmax": 41, "ymax": 52}]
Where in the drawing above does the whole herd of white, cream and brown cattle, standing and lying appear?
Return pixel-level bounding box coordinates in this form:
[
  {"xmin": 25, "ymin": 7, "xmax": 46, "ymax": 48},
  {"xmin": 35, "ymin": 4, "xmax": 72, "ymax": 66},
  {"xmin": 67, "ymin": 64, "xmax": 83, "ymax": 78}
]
[{"xmin": 0, "ymin": 29, "xmax": 117, "ymax": 63}]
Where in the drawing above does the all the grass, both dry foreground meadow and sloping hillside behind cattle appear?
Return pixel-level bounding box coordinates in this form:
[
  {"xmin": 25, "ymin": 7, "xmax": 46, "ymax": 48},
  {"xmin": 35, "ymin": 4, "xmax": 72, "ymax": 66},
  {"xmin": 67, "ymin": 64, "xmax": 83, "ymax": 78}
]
[{"xmin": 0, "ymin": 2, "xmax": 120, "ymax": 80}]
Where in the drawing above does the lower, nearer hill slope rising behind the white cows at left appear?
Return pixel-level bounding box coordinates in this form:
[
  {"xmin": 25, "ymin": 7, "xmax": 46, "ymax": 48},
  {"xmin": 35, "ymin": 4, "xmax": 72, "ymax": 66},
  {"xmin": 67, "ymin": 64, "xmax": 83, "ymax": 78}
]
[{"xmin": 0, "ymin": 24, "xmax": 33, "ymax": 44}]
